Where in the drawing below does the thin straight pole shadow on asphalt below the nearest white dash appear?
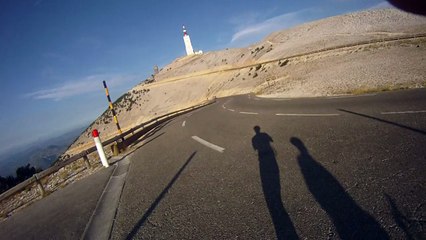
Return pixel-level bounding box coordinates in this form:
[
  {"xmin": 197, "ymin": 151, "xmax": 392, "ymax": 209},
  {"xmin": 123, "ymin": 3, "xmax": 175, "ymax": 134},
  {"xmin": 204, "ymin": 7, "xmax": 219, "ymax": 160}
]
[{"xmin": 126, "ymin": 152, "xmax": 197, "ymax": 239}]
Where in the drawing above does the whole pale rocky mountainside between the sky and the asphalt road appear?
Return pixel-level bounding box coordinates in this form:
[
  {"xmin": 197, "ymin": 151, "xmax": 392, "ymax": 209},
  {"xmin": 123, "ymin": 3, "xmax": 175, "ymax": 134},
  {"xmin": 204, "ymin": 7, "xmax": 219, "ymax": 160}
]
[{"xmin": 61, "ymin": 9, "xmax": 426, "ymax": 158}]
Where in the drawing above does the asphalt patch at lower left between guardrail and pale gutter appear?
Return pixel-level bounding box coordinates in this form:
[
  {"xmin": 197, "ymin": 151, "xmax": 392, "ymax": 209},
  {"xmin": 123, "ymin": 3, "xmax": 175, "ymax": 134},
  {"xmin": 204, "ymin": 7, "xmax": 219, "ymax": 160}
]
[{"xmin": 0, "ymin": 167, "xmax": 114, "ymax": 240}]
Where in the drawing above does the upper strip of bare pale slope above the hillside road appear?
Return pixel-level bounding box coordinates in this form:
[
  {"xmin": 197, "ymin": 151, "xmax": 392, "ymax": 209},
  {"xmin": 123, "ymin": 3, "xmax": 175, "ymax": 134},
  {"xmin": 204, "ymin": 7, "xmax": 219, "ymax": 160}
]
[{"xmin": 156, "ymin": 9, "xmax": 426, "ymax": 81}]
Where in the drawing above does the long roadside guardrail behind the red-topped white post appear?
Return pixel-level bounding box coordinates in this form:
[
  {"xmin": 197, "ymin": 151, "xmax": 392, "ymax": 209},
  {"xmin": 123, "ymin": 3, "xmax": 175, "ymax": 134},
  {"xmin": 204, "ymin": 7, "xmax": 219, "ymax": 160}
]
[{"xmin": 0, "ymin": 99, "xmax": 216, "ymax": 202}]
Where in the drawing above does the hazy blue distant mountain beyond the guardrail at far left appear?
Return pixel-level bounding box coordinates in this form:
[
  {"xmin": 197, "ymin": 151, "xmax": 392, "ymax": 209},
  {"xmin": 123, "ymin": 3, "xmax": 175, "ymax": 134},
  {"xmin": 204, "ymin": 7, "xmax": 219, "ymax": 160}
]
[{"xmin": 0, "ymin": 127, "xmax": 85, "ymax": 177}]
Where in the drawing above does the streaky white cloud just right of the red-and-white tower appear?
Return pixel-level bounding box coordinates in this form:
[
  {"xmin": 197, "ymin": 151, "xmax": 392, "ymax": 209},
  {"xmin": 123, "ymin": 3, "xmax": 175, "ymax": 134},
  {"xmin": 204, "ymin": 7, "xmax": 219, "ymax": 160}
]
[{"xmin": 231, "ymin": 9, "xmax": 317, "ymax": 44}]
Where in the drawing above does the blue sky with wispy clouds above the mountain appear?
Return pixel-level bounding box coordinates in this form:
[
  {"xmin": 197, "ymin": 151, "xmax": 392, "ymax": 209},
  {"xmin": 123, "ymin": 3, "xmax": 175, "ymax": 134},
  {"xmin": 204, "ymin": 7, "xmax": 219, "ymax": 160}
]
[{"xmin": 0, "ymin": 0, "xmax": 388, "ymax": 153}]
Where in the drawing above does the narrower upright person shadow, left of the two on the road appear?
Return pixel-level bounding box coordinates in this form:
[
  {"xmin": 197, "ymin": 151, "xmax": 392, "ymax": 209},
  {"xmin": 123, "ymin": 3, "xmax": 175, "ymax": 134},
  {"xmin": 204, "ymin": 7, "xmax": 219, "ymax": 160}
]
[{"xmin": 251, "ymin": 126, "xmax": 299, "ymax": 239}]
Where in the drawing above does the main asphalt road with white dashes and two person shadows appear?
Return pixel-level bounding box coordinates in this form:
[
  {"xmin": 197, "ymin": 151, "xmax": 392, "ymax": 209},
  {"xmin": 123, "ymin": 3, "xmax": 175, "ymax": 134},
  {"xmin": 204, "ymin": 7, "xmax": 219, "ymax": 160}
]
[{"xmin": 111, "ymin": 90, "xmax": 426, "ymax": 239}]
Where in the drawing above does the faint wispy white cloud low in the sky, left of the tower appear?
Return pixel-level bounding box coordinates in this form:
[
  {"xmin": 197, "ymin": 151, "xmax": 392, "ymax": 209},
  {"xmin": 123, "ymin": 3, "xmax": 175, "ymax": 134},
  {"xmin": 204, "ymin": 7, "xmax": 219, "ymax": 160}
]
[{"xmin": 25, "ymin": 74, "xmax": 136, "ymax": 101}]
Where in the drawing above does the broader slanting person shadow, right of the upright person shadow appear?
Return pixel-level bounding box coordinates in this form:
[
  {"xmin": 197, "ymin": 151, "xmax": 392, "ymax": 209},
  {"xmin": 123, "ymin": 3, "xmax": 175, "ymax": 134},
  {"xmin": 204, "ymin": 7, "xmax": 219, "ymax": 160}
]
[{"xmin": 290, "ymin": 137, "xmax": 389, "ymax": 239}]
